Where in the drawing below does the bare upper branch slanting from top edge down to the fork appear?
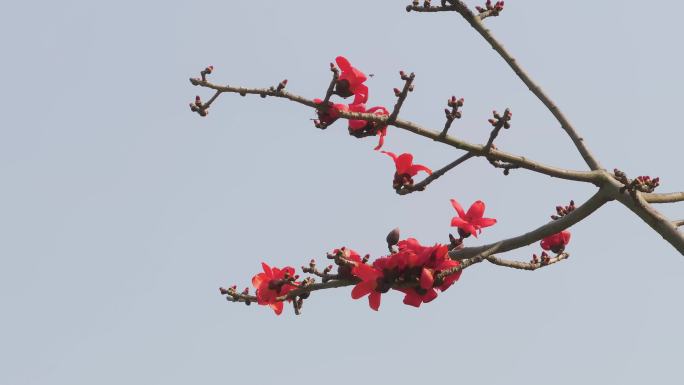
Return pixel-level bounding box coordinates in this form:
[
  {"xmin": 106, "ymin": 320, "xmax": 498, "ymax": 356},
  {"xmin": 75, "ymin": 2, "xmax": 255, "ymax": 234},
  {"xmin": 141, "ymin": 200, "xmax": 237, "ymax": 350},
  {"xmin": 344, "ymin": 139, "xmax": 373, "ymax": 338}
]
[{"xmin": 406, "ymin": 0, "xmax": 602, "ymax": 170}]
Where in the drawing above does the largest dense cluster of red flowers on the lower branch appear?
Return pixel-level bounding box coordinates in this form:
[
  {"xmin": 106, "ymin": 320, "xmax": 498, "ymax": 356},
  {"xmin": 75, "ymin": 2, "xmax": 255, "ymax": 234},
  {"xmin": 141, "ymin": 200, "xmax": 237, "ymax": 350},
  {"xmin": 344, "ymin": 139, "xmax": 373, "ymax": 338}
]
[{"xmin": 351, "ymin": 238, "xmax": 461, "ymax": 310}]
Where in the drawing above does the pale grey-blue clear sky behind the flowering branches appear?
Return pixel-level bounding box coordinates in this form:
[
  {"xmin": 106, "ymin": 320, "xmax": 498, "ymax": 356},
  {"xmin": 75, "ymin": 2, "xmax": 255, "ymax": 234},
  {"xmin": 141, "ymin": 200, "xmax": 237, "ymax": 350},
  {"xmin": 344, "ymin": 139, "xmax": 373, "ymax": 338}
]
[{"xmin": 0, "ymin": 0, "xmax": 684, "ymax": 385}]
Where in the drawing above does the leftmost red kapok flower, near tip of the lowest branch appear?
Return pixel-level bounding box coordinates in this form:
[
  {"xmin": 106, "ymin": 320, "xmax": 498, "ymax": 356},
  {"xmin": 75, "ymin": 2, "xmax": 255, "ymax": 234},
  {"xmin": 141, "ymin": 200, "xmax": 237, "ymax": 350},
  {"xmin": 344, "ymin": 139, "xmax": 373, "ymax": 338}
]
[{"xmin": 252, "ymin": 262, "xmax": 295, "ymax": 315}]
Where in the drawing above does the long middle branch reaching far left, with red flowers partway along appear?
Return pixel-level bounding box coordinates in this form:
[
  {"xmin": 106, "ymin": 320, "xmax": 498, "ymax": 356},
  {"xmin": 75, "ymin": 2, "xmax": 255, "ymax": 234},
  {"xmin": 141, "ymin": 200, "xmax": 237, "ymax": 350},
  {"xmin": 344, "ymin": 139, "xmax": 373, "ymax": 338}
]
[{"xmin": 190, "ymin": 78, "xmax": 600, "ymax": 184}]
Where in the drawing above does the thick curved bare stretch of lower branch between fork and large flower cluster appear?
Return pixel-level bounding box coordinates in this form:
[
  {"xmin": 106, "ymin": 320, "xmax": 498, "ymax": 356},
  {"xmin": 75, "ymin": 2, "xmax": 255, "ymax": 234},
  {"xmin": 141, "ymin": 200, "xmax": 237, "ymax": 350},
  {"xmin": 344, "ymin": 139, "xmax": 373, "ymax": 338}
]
[{"xmin": 449, "ymin": 188, "xmax": 611, "ymax": 260}]
